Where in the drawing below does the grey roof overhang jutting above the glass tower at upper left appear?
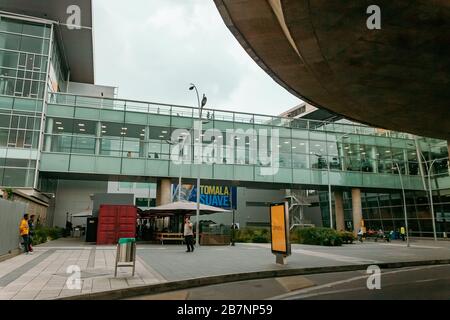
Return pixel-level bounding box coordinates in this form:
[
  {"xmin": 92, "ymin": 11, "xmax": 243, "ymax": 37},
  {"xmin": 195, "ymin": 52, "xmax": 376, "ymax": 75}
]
[{"xmin": 0, "ymin": 0, "xmax": 94, "ymax": 84}]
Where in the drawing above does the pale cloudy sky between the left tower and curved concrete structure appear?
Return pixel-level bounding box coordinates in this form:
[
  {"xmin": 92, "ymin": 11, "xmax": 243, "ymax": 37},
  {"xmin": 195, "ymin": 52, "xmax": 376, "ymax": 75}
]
[{"xmin": 93, "ymin": 0, "xmax": 300, "ymax": 115}]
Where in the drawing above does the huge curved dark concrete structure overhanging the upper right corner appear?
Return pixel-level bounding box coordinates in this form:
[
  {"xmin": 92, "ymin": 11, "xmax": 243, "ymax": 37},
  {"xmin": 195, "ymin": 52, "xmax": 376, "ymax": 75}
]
[{"xmin": 214, "ymin": 0, "xmax": 450, "ymax": 140}]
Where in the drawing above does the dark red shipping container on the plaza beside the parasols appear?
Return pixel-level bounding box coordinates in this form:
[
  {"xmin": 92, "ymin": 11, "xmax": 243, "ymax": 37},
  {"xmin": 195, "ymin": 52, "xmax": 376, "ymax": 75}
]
[{"xmin": 97, "ymin": 205, "xmax": 137, "ymax": 244}]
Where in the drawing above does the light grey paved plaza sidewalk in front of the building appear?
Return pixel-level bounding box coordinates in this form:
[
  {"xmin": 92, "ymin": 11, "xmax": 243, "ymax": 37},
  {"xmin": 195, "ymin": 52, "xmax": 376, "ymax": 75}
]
[{"xmin": 0, "ymin": 239, "xmax": 450, "ymax": 299}]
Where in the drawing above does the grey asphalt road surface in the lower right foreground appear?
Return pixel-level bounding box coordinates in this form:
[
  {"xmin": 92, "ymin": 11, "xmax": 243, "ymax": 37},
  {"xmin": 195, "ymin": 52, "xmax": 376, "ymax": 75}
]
[{"xmin": 134, "ymin": 265, "xmax": 450, "ymax": 300}]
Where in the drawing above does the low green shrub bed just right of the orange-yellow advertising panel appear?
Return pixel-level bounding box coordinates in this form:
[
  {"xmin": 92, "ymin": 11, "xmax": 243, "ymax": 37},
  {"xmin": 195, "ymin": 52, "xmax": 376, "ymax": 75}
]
[{"xmin": 291, "ymin": 228, "xmax": 342, "ymax": 246}]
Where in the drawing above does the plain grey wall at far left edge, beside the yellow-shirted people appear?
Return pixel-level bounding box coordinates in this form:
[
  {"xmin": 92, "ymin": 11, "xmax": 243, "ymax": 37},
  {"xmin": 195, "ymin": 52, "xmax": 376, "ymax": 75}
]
[{"xmin": 0, "ymin": 199, "xmax": 26, "ymax": 256}]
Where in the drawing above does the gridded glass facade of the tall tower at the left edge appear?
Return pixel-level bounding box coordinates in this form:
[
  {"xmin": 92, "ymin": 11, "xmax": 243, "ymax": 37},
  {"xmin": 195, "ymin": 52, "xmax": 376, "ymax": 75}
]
[{"xmin": 0, "ymin": 16, "xmax": 51, "ymax": 187}]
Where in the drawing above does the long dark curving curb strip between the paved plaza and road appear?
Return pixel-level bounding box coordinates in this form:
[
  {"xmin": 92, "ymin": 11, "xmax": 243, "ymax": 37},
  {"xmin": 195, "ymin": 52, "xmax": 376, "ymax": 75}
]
[{"xmin": 55, "ymin": 259, "xmax": 450, "ymax": 300}]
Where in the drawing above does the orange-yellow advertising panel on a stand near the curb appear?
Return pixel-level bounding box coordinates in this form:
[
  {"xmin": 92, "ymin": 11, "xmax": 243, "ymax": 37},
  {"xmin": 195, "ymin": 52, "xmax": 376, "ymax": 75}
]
[{"xmin": 270, "ymin": 203, "xmax": 291, "ymax": 255}]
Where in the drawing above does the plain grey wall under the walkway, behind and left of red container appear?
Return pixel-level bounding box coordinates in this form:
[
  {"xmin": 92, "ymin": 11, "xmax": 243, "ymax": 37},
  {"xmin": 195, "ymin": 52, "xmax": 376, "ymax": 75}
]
[{"xmin": 53, "ymin": 180, "xmax": 108, "ymax": 227}]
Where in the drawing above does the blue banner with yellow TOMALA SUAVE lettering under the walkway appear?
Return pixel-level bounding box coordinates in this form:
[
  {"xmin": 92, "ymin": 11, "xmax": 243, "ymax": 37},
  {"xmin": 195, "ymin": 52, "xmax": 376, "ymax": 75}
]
[{"xmin": 172, "ymin": 184, "xmax": 237, "ymax": 210}]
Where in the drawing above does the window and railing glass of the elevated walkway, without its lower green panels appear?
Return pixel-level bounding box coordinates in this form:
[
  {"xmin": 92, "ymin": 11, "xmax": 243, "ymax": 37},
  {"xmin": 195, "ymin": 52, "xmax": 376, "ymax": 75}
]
[{"xmin": 40, "ymin": 93, "xmax": 444, "ymax": 186}]
